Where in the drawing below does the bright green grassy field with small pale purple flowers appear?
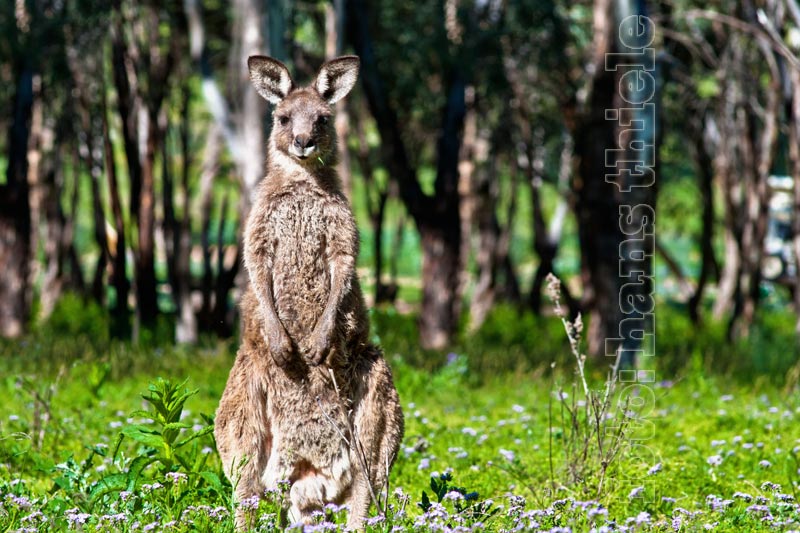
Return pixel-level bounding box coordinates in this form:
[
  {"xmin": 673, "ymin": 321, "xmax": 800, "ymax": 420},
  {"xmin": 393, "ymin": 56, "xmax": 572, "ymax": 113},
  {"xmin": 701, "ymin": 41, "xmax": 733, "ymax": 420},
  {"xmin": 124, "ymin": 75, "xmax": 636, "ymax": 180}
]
[{"xmin": 0, "ymin": 300, "xmax": 800, "ymax": 532}]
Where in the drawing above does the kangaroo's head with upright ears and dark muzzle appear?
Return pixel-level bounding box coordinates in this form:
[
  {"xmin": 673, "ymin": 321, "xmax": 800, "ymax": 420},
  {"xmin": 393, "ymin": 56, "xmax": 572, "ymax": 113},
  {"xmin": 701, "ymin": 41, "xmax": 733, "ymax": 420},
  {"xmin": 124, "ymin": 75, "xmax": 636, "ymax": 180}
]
[{"xmin": 247, "ymin": 56, "xmax": 359, "ymax": 165}]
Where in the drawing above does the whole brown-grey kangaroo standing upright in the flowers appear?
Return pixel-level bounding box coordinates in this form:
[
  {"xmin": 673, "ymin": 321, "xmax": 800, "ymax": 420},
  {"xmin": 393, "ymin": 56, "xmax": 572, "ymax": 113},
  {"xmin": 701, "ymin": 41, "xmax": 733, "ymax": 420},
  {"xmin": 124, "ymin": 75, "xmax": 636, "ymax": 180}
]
[{"xmin": 214, "ymin": 56, "xmax": 403, "ymax": 530}]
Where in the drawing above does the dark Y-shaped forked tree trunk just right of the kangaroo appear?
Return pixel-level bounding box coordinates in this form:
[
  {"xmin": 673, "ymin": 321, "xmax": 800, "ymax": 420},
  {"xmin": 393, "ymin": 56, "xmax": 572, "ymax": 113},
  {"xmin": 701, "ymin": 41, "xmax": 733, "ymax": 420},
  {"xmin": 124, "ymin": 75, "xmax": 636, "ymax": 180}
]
[{"xmin": 347, "ymin": 0, "xmax": 466, "ymax": 349}]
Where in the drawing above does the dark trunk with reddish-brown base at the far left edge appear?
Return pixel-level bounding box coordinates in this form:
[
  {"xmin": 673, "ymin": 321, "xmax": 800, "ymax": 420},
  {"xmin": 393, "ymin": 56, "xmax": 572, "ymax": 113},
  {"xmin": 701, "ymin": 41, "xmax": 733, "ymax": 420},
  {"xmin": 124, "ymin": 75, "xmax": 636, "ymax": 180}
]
[{"xmin": 0, "ymin": 63, "xmax": 33, "ymax": 337}]
